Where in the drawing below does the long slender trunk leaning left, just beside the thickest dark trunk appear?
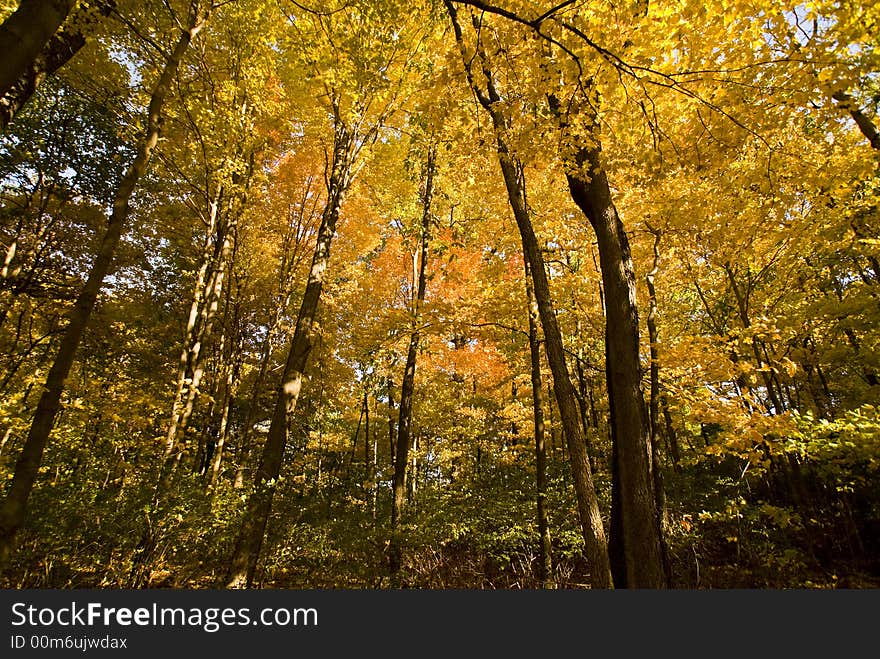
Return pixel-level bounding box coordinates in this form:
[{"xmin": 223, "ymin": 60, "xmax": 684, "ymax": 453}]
[{"xmin": 445, "ymin": 0, "xmax": 613, "ymax": 588}]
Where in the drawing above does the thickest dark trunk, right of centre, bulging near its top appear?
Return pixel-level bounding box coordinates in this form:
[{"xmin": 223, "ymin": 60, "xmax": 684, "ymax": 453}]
[{"xmin": 550, "ymin": 93, "xmax": 666, "ymax": 588}]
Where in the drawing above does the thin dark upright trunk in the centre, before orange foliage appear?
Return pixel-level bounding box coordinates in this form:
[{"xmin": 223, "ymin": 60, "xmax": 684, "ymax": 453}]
[{"xmin": 388, "ymin": 145, "xmax": 437, "ymax": 585}]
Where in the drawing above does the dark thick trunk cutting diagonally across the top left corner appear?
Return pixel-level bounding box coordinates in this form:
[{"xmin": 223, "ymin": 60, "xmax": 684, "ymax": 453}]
[{"xmin": 0, "ymin": 0, "xmax": 76, "ymax": 102}]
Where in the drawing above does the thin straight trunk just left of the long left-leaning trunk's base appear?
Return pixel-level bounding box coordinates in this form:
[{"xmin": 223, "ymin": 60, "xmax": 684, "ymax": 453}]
[{"xmin": 525, "ymin": 261, "xmax": 553, "ymax": 588}]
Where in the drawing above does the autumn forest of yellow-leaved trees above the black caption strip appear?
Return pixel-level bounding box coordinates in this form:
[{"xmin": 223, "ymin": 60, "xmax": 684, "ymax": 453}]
[{"xmin": 0, "ymin": 0, "xmax": 880, "ymax": 589}]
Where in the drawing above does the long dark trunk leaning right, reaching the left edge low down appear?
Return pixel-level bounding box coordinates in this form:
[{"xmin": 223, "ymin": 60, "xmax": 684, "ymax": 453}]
[{"xmin": 0, "ymin": 9, "xmax": 207, "ymax": 564}]
